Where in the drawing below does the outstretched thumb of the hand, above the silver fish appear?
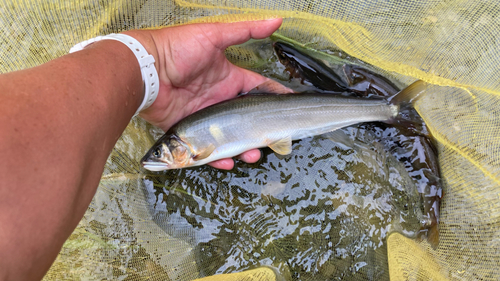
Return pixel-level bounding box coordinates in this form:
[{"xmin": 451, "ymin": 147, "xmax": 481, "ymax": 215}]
[{"xmin": 213, "ymin": 18, "xmax": 283, "ymax": 50}]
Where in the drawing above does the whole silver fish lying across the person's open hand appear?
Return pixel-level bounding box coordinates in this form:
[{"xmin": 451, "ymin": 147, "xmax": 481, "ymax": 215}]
[{"xmin": 142, "ymin": 81, "xmax": 425, "ymax": 171}]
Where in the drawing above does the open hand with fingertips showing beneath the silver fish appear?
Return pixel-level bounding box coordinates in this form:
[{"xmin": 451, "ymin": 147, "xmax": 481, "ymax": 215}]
[{"xmin": 124, "ymin": 19, "xmax": 282, "ymax": 169}]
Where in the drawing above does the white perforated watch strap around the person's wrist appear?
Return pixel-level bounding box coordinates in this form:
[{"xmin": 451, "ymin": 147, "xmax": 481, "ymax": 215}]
[{"xmin": 69, "ymin": 33, "xmax": 160, "ymax": 116}]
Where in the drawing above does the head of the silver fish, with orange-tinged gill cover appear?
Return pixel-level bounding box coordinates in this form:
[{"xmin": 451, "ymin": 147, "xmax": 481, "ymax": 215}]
[{"xmin": 141, "ymin": 134, "xmax": 193, "ymax": 171}]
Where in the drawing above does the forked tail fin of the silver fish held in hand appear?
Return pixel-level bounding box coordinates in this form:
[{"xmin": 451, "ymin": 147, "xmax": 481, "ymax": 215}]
[{"xmin": 387, "ymin": 80, "xmax": 430, "ymax": 136}]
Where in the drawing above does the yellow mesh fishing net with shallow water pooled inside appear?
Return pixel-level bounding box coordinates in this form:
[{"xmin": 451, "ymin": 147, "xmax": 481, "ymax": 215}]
[{"xmin": 0, "ymin": 0, "xmax": 500, "ymax": 280}]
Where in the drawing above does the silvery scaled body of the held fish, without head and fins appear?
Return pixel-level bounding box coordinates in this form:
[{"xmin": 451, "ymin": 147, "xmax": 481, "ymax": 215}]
[{"xmin": 172, "ymin": 94, "xmax": 397, "ymax": 165}]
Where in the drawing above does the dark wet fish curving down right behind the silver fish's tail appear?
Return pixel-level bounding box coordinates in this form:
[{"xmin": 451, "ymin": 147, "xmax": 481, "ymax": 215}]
[{"xmin": 344, "ymin": 65, "xmax": 443, "ymax": 248}]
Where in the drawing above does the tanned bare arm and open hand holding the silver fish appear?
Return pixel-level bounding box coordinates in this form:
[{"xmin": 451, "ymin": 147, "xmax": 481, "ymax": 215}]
[{"xmin": 0, "ymin": 19, "xmax": 281, "ymax": 280}]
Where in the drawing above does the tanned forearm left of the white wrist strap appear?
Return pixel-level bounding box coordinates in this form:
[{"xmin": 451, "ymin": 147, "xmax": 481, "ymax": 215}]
[{"xmin": 0, "ymin": 40, "xmax": 144, "ymax": 280}]
